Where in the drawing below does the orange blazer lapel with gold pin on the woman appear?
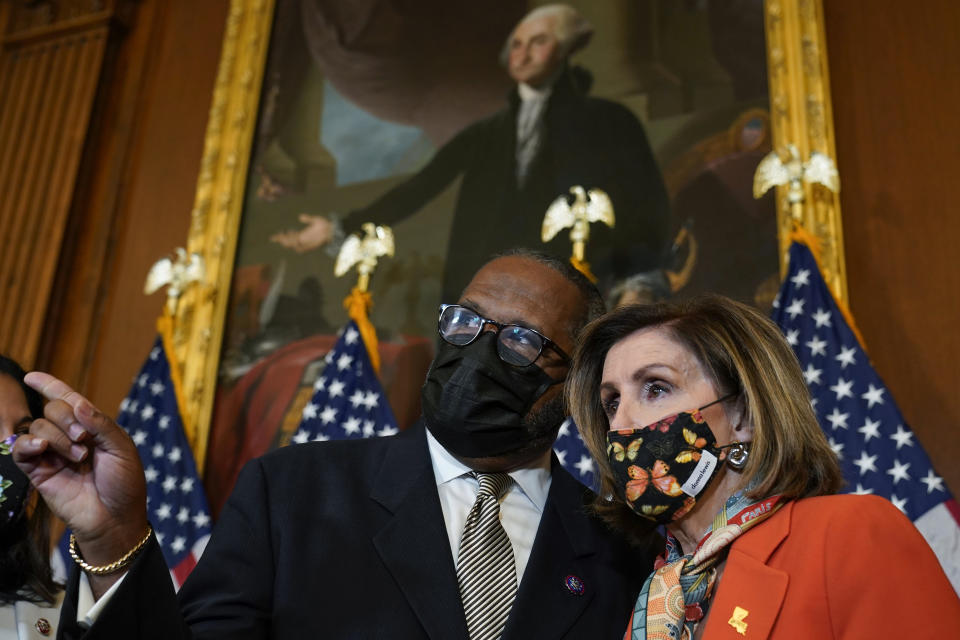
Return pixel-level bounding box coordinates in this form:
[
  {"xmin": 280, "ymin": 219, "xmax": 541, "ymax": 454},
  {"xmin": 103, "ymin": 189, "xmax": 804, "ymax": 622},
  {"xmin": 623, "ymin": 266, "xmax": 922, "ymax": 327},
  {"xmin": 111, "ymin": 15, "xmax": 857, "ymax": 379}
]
[{"xmin": 703, "ymin": 502, "xmax": 794, "ymax": 640}]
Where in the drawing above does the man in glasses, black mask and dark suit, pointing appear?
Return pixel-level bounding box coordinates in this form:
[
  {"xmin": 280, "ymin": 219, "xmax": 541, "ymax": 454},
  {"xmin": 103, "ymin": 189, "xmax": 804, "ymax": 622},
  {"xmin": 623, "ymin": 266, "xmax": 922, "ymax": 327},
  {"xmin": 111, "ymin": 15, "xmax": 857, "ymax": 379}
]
[{"xmin": 14, "ymin": 252, "xmax": 653, "ymax": 639}]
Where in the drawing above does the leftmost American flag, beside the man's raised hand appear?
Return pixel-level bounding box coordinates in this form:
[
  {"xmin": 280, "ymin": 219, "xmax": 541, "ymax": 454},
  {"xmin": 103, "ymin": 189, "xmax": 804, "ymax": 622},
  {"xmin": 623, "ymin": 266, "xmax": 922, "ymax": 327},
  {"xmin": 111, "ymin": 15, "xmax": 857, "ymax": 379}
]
[{"xmin": 117, "ymin": 337, "xmax": 211, "ymax": 589}]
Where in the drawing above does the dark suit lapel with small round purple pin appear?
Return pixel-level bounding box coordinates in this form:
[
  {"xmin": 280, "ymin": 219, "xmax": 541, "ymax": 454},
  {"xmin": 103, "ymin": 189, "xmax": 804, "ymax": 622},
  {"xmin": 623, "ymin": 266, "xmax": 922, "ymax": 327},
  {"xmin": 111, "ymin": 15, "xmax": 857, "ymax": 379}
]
[{"xmin": 503, "ymin": 456, "xmax": 597, "ymax": 640}]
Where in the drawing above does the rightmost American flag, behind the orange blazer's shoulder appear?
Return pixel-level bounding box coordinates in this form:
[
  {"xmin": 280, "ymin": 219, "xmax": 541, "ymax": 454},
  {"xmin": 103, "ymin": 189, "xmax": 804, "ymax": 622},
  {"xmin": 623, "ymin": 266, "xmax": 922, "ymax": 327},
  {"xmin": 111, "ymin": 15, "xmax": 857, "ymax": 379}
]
[{"xmin": 772, "ymin": 242, "xmax": 960, "ymax": 592}]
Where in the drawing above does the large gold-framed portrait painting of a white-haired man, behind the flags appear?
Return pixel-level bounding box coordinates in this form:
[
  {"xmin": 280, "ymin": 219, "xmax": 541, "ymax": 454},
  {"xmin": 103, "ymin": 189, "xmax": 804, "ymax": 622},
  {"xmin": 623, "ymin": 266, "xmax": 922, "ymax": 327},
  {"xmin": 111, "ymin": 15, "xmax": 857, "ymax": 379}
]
[{"xmin": 169, "ymin": 0, "xmax": 843, "ymax": 511}]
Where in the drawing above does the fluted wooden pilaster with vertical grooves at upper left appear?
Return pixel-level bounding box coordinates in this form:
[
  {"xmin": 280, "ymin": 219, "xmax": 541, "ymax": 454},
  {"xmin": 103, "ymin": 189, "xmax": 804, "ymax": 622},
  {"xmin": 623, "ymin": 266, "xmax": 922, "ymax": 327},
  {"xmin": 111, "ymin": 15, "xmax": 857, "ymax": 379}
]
[{"xmin": 0, "ymin": 21, "xmax": 108, "ymax": 364}]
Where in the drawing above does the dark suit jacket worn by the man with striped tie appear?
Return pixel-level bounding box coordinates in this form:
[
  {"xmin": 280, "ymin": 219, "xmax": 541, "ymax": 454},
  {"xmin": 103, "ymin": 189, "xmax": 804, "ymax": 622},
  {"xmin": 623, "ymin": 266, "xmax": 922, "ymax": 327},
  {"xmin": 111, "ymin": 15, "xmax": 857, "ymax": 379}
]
[{"xmin": 61, "ymin": 425, "xmax": 653, "ymax": 640}]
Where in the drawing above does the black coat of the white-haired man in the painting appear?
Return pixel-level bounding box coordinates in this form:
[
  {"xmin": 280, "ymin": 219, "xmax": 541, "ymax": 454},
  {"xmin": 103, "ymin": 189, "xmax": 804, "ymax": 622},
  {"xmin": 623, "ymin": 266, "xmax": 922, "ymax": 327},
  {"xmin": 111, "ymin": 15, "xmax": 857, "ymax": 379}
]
[{"xmin": 343, "ymin": 68, "xmax": 670, "ymax": 302}]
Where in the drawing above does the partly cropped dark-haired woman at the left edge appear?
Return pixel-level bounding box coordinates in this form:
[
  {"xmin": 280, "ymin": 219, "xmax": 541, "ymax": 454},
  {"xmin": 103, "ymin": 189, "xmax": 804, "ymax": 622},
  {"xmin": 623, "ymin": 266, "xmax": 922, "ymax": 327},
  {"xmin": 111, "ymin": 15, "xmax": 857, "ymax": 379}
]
[{"xmin": 0, "ymin": 355, "xmax": 63, "ymax": 640}]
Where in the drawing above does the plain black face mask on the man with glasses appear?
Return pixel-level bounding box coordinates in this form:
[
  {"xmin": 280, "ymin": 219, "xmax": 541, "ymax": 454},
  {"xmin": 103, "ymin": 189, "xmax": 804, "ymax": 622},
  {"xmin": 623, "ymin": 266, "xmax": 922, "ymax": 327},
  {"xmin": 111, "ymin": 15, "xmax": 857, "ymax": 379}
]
[{"xmin": 421, "ymin": 331, "xmax": 562, "ymax": 458}]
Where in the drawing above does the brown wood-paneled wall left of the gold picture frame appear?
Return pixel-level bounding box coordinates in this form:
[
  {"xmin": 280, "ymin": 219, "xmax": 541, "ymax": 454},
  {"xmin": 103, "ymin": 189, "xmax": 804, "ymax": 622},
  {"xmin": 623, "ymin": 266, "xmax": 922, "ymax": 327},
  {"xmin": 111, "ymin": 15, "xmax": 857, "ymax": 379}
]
[{"xmin": 0, "ymin": 0, "xmax": 228, "ymax": 411}]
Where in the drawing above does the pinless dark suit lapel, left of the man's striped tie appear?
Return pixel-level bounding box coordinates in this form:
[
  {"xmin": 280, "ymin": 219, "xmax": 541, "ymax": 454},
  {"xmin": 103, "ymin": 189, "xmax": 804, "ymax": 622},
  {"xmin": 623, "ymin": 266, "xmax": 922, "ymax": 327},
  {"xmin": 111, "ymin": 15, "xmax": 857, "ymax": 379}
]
[{"xmin": 370, "ymin": 425, "xmax": 467, "ymax": 639}]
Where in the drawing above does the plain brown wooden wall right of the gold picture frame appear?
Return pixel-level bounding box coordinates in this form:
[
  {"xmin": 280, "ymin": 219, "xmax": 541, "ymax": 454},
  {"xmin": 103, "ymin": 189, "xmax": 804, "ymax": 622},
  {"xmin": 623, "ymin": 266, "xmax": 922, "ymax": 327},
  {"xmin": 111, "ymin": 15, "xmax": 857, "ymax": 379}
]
[{"xmin": 824, "ymin": 0, "xmax": 960, "ymax": 496}]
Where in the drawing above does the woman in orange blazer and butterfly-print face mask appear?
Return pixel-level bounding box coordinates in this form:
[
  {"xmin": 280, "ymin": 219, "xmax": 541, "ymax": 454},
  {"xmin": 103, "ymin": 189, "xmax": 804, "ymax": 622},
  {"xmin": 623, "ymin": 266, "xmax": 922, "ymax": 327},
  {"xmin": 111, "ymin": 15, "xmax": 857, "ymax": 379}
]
[{"xmin": 567, "ymin": 296, "xmax": 960, "ymax": 640}]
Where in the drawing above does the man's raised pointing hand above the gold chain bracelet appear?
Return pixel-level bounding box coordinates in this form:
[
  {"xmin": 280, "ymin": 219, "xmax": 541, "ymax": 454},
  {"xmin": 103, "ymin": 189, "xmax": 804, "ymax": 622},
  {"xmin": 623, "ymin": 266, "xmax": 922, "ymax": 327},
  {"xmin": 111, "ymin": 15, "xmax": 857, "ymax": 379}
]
[{"xmin": 13, "ymin": 371, "xmax": 147, "ymax": 576}]
